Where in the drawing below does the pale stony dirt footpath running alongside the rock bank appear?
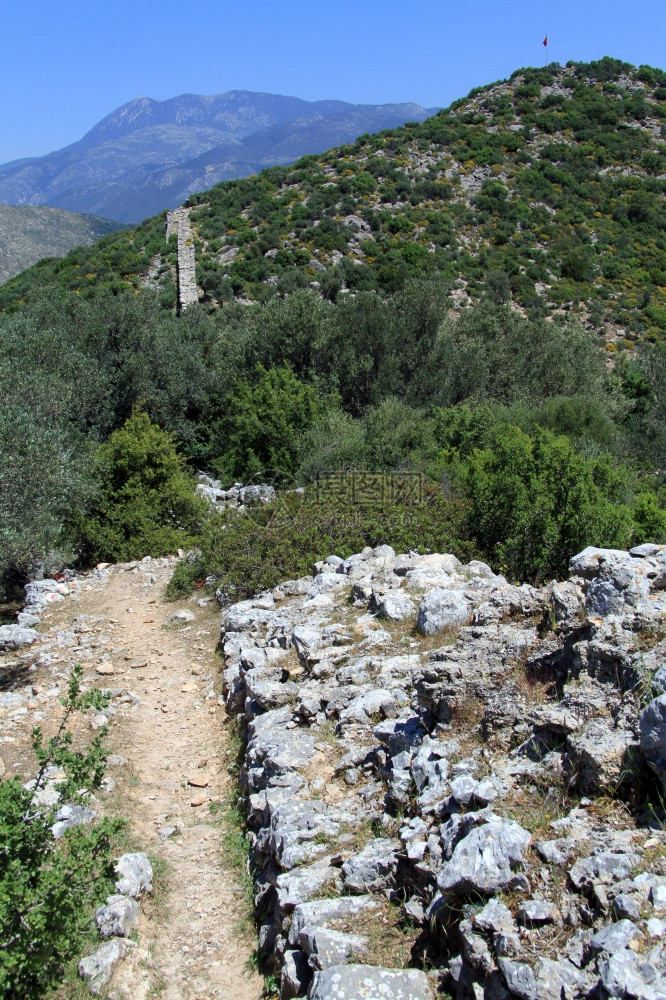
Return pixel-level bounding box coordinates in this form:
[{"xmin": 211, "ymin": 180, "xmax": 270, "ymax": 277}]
[{"xmin": 0, "ymin": 559, "xmax": 262, "ymax": 1000}]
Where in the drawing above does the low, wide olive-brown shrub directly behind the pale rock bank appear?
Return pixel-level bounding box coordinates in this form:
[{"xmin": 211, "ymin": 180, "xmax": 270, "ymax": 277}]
[{"xmin": 167, "ymin": 482, "xmax": 474, "ymax": 601}]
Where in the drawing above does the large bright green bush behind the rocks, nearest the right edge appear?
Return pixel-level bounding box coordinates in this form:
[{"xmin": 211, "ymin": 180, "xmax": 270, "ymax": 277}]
[{"xmin": 461, "ymin": 425, "xmax": 666, "ymax": 581}]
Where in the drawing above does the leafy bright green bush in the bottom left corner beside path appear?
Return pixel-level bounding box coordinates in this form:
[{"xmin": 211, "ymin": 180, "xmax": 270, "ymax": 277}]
[{"xmin": 0, "ymin": 667, "xmax": 121, "ymax": 1000}]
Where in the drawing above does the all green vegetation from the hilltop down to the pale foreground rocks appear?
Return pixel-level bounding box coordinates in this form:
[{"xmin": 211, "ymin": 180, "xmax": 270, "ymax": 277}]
[{"xmin": 0, "ymin": 59, "xmax": 666, "ymax": 593}]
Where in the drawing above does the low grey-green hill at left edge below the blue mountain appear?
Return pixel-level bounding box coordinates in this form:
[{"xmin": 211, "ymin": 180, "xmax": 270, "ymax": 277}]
[{"xmin": 0, "ymin": 205, "xmax": 123, "ymax": 284}]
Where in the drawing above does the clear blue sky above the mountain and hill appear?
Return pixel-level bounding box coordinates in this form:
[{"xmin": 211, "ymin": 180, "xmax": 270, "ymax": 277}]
[{"xmin": 0, "ymin": 0, "xmax": 666, "ymax": 163}]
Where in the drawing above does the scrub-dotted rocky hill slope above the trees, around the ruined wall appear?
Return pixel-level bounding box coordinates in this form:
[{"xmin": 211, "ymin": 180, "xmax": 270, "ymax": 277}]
[{"xmin": 5, "ymin": 59, "xmax": 666, "ymax": 349}]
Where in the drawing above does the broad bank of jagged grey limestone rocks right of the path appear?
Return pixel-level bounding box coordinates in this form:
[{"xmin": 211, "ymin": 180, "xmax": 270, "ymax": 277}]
[{"xmin": 221, "ymin": 545, "xmax": 666, "ymax": 1000}]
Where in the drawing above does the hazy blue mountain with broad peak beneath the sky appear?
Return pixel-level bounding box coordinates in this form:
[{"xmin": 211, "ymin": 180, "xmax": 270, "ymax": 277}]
[{"xmin": 0, "ymin": 90, "xmax": 438, "ymax": 222}]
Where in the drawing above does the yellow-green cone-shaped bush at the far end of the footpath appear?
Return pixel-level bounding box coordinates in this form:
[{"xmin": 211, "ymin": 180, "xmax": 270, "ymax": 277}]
[{"xmin": 72, "ymin": 409, "xmax": 206, "ymax": 563}]
